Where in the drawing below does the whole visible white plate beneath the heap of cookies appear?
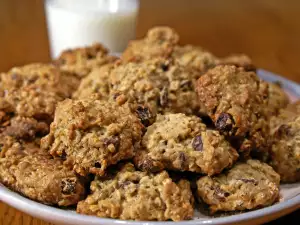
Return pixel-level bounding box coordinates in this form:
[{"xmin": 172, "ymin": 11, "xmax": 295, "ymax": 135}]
[{"xmin": 0, "ymin": 70, "xmax": 300, "ymax": 225}]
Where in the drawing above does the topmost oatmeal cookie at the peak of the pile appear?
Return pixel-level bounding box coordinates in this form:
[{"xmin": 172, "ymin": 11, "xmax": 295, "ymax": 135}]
[{"xmin": 121, "ymin": 27, "xmax": 179, "ymax": 62}]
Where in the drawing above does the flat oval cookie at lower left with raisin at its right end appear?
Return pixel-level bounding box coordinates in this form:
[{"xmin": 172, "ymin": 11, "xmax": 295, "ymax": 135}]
[{"xmin": 0, "ymin": 137, "xmax": 85, "ymax": 206}]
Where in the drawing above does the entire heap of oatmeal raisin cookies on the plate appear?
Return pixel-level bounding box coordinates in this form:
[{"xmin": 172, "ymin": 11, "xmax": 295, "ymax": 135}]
[{"xmin": 0, "ymin": 27, "xmax": 300, "ymax": 221}]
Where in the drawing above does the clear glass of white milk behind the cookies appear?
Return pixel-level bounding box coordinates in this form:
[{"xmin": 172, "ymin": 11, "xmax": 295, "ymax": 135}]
[{"xmin": 45, "ymin": 0, "xmax": 139, "ymax": 58}]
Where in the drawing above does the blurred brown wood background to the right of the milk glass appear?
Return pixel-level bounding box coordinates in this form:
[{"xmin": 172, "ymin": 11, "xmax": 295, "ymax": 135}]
[{"xmin": 137, "ymin": 0, "xmax": 300, "ymax": 82}]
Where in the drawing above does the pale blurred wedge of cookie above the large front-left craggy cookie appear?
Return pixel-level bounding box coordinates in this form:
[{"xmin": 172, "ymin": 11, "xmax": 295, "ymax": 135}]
[{"xmin": 73, "ymin": 64, "xmax": 113, "ymax": 99}]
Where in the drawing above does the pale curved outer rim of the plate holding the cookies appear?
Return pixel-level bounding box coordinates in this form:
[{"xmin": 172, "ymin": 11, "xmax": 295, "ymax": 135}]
[{"xmin": 0, "ymin": 69, "xmax": 300, "ymax": 225}]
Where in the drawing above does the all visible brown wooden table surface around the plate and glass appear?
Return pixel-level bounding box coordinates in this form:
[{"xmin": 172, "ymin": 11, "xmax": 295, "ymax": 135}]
[{"xmin": 0, "ymin": 0, "xmax": 300, "ymax": 225}]
